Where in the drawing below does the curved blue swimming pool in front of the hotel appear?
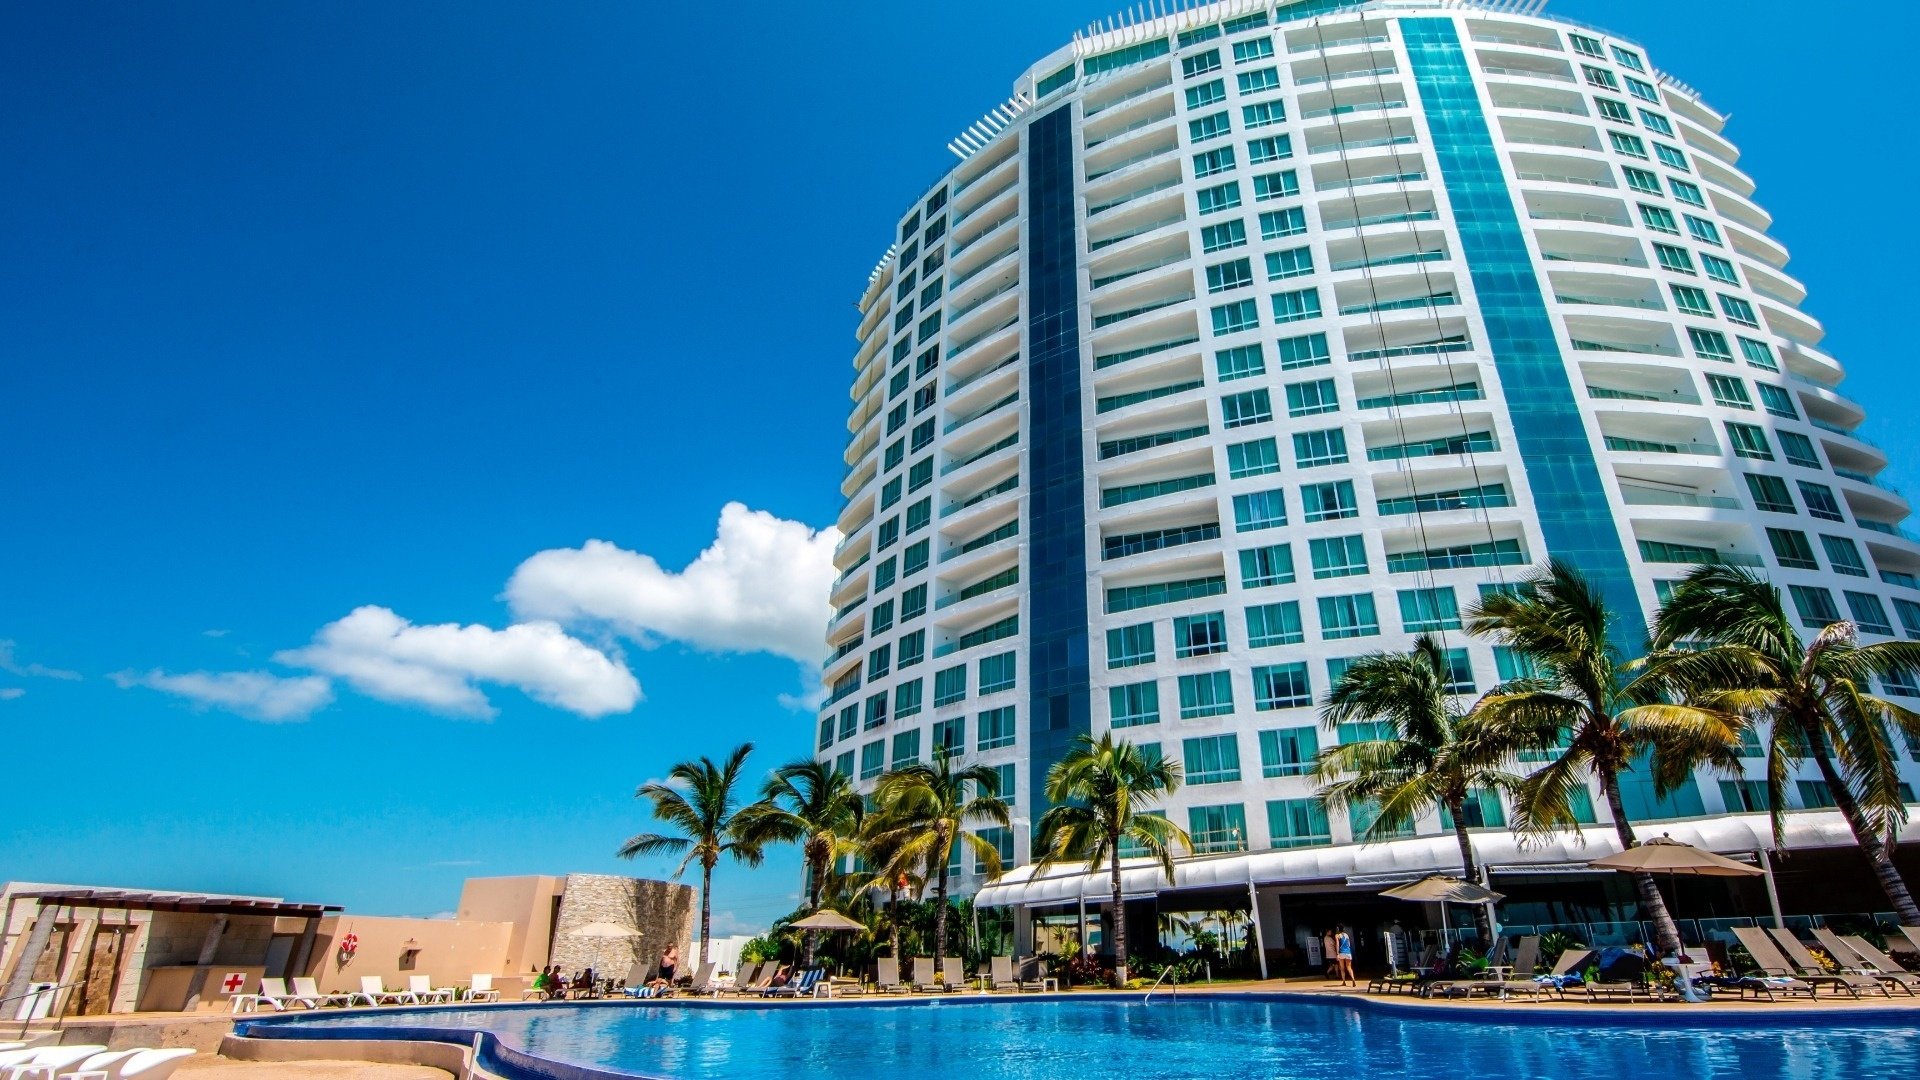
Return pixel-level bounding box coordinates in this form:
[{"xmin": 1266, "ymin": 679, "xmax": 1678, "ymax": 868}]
[{"xmin": 242, "ymin": 994, "xmax": 1920, "ymax": 1080}]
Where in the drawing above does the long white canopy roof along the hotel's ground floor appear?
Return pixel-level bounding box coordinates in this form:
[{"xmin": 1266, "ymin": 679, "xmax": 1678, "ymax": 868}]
[{"xmin": 973, "ymin": 811, "xmax": 1920, "ymax": 907}]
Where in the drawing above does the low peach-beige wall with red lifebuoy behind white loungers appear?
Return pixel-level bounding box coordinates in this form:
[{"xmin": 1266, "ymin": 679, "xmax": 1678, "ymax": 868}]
[{"xmin": 307, "ymin": 915, "xmax": 513, "ymax": 994}]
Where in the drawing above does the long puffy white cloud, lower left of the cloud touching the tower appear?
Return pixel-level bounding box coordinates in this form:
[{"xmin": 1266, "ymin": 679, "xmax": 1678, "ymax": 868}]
[{"xmin": 275, "ymin": 605, "xmax": 639, "ymax": 717}]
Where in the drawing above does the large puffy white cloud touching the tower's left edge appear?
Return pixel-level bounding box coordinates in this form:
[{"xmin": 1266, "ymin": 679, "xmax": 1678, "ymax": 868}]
[{"xmin": 507, "ymin": 502, "xmax": 839, "ymax": 665}]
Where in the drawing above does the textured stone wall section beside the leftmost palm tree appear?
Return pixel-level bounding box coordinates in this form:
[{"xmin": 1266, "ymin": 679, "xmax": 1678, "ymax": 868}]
[{"xmin": 549, "ymin": 874, "xmax": 695, "ymax": 978}]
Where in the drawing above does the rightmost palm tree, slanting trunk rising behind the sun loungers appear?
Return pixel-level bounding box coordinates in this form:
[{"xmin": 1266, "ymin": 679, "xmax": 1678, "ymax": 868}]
[{"xmin": 1653, "ymin": 567, "xmax": 1920, "ymax": 926}]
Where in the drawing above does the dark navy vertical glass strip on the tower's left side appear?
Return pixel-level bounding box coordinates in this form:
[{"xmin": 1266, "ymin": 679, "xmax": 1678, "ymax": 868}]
[{"xmin": 1027, "ymin": 106, "xmax": 1092, "ymax": 817}]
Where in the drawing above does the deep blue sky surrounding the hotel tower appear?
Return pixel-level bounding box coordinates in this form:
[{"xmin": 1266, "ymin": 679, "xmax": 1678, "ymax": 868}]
[{"xmin": 0, "ymin": 0, "xmax": 1920, "ymax": 928}]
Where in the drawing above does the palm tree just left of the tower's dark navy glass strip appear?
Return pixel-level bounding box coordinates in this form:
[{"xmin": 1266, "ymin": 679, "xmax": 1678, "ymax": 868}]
[{"xmin": 872, "ymin": 751, "xmax": 1012, "ymax": 969}]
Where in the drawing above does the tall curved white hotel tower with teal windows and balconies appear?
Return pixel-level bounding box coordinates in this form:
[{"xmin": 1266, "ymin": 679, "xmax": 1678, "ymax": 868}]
[{"xmin": 818, "ymin": 0, "xmax": 1920, "ymax": 888}]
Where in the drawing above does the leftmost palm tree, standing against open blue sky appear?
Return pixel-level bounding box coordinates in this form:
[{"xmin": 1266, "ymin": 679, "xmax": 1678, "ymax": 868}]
[{"xmin": 616, "ymin": 742, "xmax": 764, "ymax": 963}]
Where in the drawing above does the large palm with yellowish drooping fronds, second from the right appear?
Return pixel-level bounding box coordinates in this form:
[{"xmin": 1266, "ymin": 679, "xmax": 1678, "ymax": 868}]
[{"xmin": 1467, "ymin": 559, "xmax": 1740, "ymax": 951}]
